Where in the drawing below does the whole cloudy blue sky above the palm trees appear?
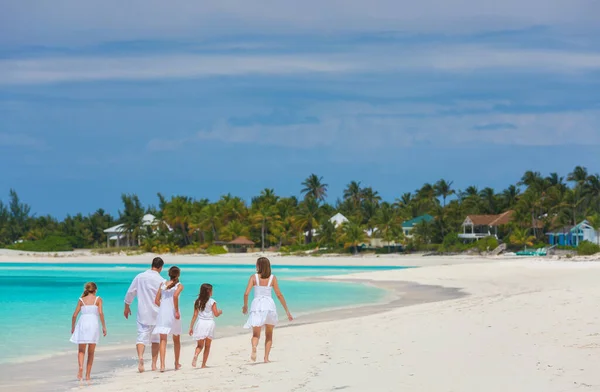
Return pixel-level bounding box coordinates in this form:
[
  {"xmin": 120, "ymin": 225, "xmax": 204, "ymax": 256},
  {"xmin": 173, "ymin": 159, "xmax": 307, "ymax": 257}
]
[{"xmin": 0, "ymin": 0, "xmax": 600, "ymax": 217}]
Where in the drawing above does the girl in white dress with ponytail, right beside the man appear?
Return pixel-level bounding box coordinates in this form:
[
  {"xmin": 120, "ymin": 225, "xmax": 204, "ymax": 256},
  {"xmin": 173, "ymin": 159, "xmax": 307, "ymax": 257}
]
[{"xmin": 153, "ymin": 266, "xmax": 183, "ymax": 372}]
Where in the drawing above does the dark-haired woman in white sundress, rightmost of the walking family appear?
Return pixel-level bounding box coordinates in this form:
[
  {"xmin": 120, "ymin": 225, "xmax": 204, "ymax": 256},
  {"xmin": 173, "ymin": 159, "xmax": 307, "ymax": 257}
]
[{"xmin": 242, "ymin": 257, "xmax": 293, "ymax": 363}]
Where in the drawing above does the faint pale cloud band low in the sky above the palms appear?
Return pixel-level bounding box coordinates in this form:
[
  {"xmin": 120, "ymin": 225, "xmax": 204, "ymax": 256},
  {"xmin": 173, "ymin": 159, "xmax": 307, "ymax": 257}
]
[{"xmin": 148, "ymin": 107, "xmax": 600, "ymax": 152}]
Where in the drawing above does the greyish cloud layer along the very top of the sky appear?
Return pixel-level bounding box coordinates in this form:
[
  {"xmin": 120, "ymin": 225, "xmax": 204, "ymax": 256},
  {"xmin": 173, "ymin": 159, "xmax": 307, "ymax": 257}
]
[{"xmin": 0, "ymin": 0, "xmax": 600, "ymax": 44}]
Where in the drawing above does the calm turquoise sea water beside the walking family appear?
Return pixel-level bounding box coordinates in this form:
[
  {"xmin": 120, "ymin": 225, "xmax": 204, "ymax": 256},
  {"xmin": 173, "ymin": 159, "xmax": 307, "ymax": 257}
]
[{"xmin": 0, "ymin": 263, "xmax": 404, "ymax": 363}]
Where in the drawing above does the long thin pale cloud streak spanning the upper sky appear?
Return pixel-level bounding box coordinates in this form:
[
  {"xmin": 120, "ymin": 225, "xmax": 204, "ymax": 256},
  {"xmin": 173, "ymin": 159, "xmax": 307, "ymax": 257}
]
[{"xmin": 0, "ymin": 45, "xmax": 600, "ymax": 84}]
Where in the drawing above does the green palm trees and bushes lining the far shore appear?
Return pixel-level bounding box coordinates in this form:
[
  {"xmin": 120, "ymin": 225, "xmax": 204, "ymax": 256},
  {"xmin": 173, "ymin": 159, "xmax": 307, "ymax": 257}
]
[{"xmin": 0, "ymin": 167, "xmax": 600, "ymax": 255}]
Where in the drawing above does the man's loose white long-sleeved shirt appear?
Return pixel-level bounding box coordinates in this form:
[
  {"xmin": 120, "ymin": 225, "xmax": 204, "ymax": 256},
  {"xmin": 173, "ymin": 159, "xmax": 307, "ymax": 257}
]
[{"xmin": 125, "ymin": 270, "xmax": 165, "ymax": 325}]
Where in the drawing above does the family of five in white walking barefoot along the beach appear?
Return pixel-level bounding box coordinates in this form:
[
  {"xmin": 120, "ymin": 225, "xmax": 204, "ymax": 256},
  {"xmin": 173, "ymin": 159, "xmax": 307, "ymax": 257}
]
[{"xmin": 71, "ymin": 257, "xmax": 292, "ymax": 381}]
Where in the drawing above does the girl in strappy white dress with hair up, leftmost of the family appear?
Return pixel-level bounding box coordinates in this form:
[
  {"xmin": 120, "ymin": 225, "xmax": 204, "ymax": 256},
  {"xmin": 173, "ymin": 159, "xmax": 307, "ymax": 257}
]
[{"xmin": 71, "ymin": 282, "xmax": 106, "ymax": 381}]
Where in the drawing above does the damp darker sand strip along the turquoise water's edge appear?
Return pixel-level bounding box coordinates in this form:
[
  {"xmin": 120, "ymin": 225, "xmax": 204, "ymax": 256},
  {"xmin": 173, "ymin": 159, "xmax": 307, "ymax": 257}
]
[{"xmin": 3, "ymin": 276, "xmax": 467, "ymax": 392}]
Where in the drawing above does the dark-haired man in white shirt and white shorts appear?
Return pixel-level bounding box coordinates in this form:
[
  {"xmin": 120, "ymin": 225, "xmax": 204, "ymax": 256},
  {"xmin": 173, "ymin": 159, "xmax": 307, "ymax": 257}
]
[{"xmin": 124, "ymin": 257, "xmax": 165, "ymax": 373}]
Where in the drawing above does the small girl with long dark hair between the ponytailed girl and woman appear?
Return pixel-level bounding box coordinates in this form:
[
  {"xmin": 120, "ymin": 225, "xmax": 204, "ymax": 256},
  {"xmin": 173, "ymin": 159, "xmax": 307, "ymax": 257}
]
[{"xmin": 190, "ymin": 283, "xmax": 223, "ymax": 368}]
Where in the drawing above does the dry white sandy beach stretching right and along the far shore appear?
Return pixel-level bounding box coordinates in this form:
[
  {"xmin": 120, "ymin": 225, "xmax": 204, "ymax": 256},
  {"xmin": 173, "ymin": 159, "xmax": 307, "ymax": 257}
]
[{"xmin": 0, "ymin": 254, "xmax": 600, "ymax": 392}]
